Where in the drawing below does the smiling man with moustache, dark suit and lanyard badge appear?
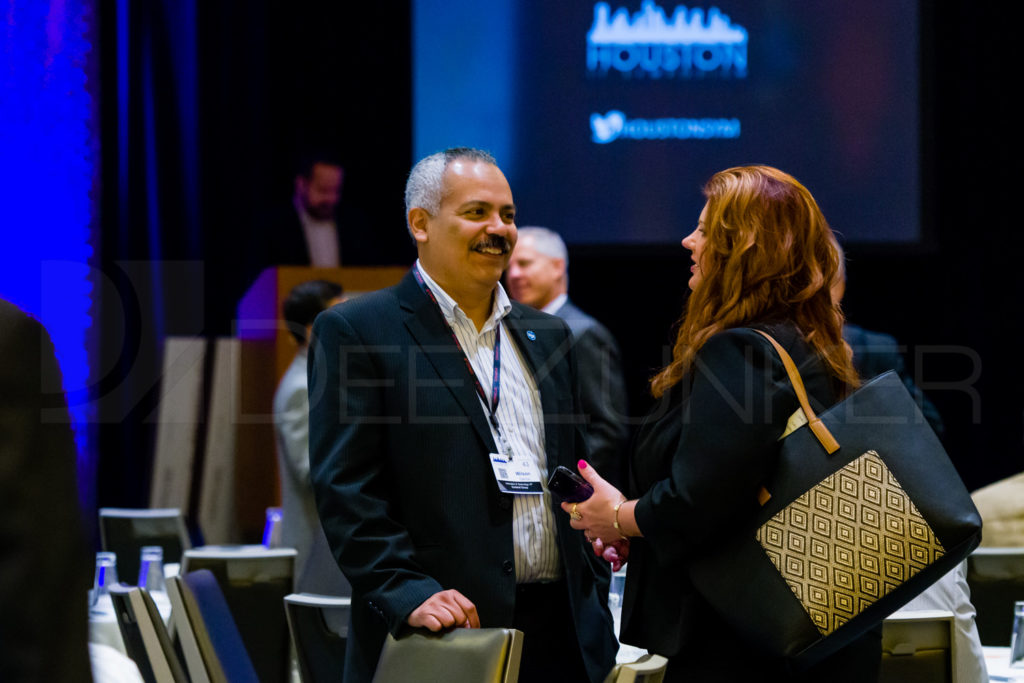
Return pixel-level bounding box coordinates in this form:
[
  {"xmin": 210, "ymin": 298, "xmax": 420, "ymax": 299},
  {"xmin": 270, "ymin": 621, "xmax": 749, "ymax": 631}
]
[{"xmin": 309, "ymin": 148, "xmax": 616, "ymax": 682}]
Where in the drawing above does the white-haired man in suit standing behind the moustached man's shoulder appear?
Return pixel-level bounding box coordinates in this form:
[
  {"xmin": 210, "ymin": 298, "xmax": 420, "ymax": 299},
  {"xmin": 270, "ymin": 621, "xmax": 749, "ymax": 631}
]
[{"xmin": 507, "ymin": 227, "xmax": 629, "ymax": 485}]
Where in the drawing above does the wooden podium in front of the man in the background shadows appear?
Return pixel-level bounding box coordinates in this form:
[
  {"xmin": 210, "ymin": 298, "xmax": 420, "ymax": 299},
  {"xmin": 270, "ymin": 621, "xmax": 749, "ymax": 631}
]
[{"xmin": 228, "ymin": 266, "xmax": 409, "ymax": 543}]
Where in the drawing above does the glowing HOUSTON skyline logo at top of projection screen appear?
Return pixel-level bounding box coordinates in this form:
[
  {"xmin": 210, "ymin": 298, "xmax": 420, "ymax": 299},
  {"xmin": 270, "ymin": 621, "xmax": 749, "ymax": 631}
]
[{"xmin": 587, "ymin": 0, "xmax": 748, "ymax": 79}]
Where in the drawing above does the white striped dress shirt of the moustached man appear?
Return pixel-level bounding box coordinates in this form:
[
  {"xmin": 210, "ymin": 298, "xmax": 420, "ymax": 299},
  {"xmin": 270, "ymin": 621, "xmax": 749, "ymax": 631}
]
[{"xmin": 415, "ymin": 261, "xmax": 562, "ymax": 584}]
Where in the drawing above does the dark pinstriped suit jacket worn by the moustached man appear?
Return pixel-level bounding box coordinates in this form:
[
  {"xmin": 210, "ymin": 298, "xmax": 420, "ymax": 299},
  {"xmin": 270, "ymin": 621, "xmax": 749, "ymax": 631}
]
[{"xmin": 309, "ymin": 272, "xmax": 616, "ymax": 682}]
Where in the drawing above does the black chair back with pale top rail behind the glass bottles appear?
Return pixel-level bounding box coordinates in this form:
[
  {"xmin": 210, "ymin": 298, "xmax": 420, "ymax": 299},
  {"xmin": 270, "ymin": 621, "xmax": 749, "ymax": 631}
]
[{"xmin": 99, "ymin": 508, "xmax": 191, "ymax": 584}]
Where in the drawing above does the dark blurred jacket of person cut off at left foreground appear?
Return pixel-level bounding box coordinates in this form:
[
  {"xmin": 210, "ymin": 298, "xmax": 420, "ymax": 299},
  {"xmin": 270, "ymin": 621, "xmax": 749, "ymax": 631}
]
[{"xmin": 0, "ymin": 300, "xmax": 92, "ymax": 683}]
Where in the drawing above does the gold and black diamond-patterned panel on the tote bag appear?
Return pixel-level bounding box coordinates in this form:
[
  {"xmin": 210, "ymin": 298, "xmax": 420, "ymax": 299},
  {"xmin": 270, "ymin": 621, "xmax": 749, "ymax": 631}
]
[{"xmin": 757, "ymin": 451, "xmax": 945, "ymax": 636}]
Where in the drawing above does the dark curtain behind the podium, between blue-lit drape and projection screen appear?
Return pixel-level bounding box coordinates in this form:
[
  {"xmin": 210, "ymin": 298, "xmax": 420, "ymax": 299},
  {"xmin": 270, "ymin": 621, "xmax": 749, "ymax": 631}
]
[{"xmin": 97, "ymin": 0, "xmax": 412, "ymax": 518}]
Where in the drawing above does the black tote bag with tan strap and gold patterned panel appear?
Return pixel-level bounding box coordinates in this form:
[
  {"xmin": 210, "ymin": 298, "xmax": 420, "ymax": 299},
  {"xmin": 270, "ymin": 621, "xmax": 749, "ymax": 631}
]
[{"xmin": 690, "ymin": 332, "xmax": 981, "ymax": 670}]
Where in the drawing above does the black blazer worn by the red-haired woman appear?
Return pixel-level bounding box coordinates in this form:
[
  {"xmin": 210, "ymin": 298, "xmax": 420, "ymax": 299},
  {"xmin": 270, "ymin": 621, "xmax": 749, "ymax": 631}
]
[{"xmin": 622, "ymin": 325, "xmax": 879, "ymax": 681}]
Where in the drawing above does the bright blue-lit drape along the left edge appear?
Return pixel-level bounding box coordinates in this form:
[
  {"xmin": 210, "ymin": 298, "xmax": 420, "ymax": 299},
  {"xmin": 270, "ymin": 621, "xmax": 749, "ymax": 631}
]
[{"xmin": 0, "ymin": 0, "xmax": 98, "ymax": 507}]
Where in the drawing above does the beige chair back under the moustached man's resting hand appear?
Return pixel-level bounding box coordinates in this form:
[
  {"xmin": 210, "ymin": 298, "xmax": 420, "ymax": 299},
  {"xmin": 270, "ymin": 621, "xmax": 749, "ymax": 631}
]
[{"xmin": 373, "ymin": 629, "xmax": 523, "ymax": 683}]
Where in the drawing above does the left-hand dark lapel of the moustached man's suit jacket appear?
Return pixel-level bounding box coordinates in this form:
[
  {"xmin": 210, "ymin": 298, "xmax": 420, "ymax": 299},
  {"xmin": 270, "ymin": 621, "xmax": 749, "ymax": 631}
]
[{"xmin": 396, "ymin": 271, "xmax": 496, "ymax": 453}]
